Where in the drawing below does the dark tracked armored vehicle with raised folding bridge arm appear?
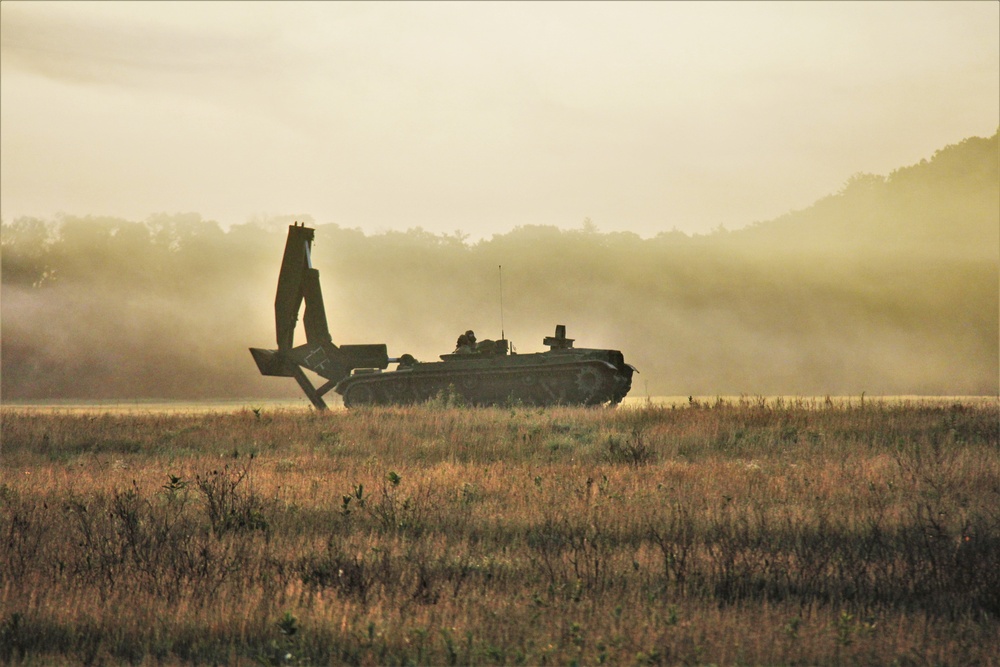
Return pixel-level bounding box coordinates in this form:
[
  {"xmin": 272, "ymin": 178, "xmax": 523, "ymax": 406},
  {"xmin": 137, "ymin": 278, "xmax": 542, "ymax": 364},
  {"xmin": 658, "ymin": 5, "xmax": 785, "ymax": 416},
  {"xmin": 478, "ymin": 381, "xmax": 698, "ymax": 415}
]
[{"xmin": 250, "ymin": 223, "xmax": 635, "ymax": 410}]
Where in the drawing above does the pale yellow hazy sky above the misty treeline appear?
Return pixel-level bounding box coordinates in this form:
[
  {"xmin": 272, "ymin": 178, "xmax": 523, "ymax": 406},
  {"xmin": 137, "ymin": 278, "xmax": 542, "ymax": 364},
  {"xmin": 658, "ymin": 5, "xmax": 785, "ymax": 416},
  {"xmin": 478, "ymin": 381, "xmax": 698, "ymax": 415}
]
[{"xmin": 0, "ymin": 0, "xmax": 1000, "ymax": 238}]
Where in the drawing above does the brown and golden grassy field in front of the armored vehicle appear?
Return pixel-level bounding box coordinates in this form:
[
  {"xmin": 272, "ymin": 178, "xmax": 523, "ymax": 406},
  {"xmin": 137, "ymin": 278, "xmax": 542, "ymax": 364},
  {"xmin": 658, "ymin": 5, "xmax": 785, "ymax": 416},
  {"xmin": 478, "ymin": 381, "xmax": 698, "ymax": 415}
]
[{"xmin": 0, "ymin": 398, "xmax": 1000, "ymax": 665}]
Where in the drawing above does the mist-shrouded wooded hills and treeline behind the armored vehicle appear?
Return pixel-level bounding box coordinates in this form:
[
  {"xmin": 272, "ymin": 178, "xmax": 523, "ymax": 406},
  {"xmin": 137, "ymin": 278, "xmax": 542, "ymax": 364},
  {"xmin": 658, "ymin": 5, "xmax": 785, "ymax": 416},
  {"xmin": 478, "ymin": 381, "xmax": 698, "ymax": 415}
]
[{"xmin": 0, "ymin": 135, "xmax": 1000, "ymax": 400}]
